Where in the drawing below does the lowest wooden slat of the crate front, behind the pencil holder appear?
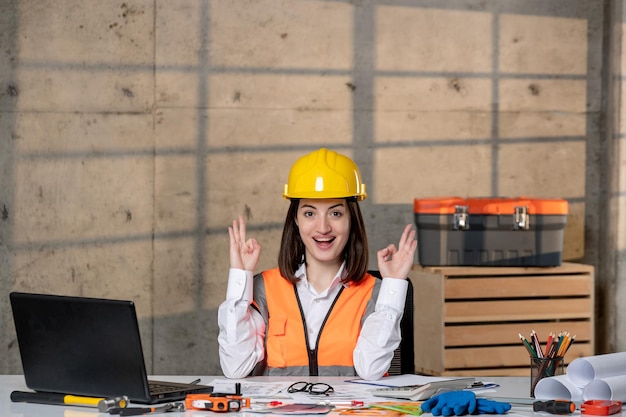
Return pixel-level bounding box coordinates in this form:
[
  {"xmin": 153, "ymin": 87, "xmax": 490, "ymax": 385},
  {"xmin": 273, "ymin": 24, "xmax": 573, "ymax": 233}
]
[{"xmin": 444, "ymin": 342, "xmax": 593, "ymax": 370}]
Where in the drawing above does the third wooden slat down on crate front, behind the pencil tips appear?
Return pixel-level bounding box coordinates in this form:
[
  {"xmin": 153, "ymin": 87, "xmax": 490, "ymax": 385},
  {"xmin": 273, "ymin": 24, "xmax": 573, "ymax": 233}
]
[{"xmin": 444, "ymin": 320, "xmax": 594, "ymax": 347}]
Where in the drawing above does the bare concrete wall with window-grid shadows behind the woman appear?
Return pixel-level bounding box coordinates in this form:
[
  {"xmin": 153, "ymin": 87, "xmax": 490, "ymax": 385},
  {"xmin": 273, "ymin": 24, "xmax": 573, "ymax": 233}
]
[{"xmin": 0, "ymin": 0, "xmax": 626, "ymax": 374}]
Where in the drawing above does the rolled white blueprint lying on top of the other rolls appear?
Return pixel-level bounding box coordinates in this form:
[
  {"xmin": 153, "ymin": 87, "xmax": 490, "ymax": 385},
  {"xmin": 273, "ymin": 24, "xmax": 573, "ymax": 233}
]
[{"xmin": 567, "ymin": 352, "xmax": 626, "ymax": 388}]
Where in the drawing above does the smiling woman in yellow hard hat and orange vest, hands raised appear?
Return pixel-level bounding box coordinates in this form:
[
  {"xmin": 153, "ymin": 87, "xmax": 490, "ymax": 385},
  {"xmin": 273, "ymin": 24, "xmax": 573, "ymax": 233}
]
[{"xmin": 218, "ymin": 148, "xmax": 417, "ymax": 380}]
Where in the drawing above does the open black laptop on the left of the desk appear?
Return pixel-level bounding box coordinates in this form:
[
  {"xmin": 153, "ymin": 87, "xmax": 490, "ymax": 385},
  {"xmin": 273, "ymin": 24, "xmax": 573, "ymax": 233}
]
[{"xmin": 10, "ymin": 292, "xmax": 211, "ymax": 404}]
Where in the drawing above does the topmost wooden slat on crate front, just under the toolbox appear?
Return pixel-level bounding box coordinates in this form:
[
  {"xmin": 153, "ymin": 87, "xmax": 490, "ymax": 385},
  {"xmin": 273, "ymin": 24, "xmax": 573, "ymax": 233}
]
[{"xmin": 445, "ymin": 275, "xmax": 593, "ymax": 300}]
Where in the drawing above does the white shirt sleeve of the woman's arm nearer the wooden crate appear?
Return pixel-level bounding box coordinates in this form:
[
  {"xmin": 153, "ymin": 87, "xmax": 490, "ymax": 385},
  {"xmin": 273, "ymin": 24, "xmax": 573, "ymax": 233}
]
[{"xmin": 354, "ymin": 278, "xmax": 409, "ymax": 380}]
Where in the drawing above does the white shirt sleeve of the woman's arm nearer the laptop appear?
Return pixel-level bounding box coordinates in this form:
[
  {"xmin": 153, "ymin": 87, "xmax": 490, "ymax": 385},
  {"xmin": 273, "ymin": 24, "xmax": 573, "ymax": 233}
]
[{"xmin": 217, "ymin": 268, "xmax": 265, "ymax": 378}]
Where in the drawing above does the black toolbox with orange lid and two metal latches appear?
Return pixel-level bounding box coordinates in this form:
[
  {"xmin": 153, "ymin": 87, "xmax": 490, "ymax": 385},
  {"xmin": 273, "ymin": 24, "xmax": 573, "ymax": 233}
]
[{"xmin": 414, "ymin": 197, "xmax": 568, "ymax": 266}]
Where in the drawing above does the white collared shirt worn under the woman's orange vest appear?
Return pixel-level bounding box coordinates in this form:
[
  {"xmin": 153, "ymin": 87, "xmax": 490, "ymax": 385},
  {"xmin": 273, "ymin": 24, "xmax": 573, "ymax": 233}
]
[{"xmin": 218, "ymin": 264, "xmax": 408, "ymax": 380}]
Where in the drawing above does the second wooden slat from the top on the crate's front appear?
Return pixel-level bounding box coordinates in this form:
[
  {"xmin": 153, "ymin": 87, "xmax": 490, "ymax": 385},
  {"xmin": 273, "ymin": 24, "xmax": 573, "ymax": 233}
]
[{"xmin": 445, "ymin": 298, "xmax": 593, "ymax": 323}]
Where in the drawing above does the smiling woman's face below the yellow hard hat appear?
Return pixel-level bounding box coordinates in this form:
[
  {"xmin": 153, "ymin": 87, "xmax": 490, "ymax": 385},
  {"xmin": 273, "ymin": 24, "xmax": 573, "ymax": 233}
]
[{"xmin": 296, "ymin": 199, "xmax": 350, "ymax": 264}]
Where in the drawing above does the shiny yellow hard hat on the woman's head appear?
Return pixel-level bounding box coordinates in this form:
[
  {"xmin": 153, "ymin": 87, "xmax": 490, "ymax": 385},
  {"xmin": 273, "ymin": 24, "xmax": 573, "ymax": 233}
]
[{"xmin": 283, "ymin": 148, "xmax": 367, "ymax": 200}]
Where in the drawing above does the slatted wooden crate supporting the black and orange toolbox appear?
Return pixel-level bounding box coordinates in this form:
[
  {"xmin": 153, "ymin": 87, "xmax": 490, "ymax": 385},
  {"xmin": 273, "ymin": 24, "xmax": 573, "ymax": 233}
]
[{"xmin": 410, "ymin": 263, "xmax": 594, "ymax": 376}]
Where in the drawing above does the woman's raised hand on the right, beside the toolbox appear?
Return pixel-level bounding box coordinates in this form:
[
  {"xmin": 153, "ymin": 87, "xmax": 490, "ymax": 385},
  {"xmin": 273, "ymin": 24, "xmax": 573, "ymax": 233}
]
[{"xmin": 376, "ymin": 224, "xmax": 417, "ymax": 279}]
